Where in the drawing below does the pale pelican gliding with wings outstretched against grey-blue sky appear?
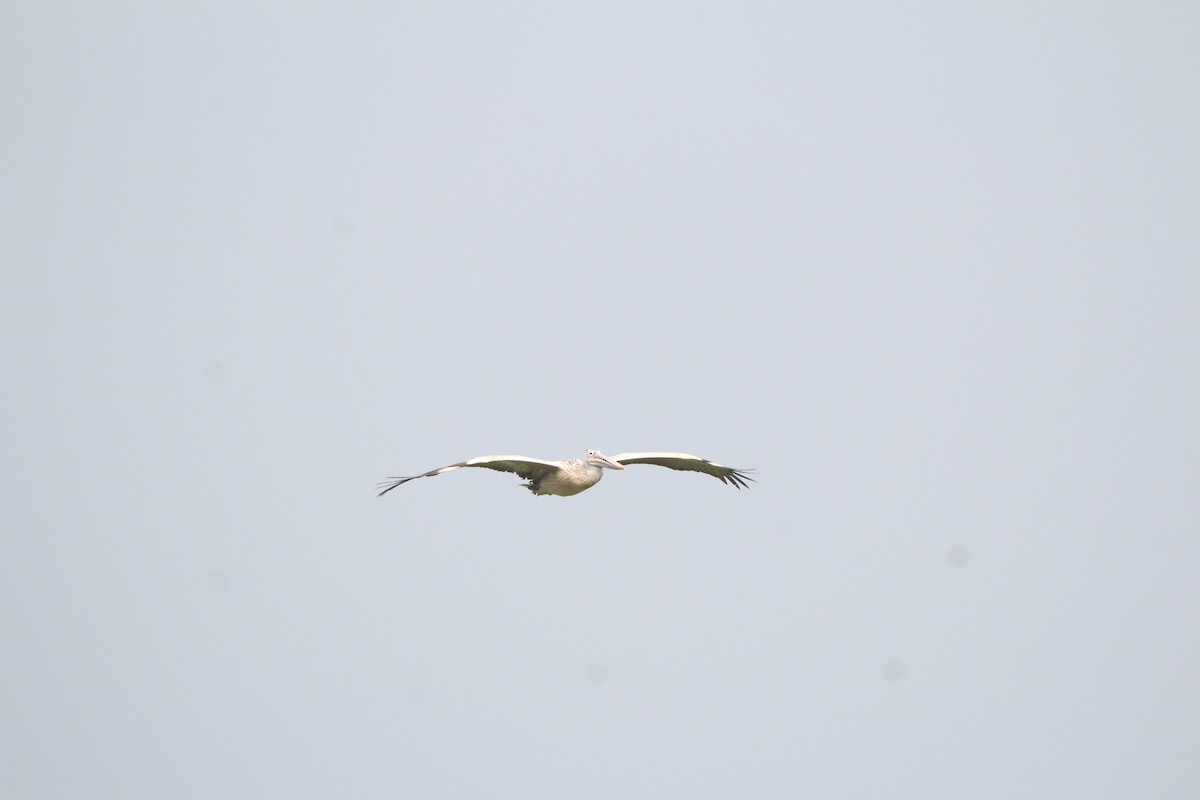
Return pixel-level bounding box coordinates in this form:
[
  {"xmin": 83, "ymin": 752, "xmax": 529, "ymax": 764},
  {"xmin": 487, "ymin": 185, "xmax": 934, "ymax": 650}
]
[{"xmin": 377, "ymin": 450, "xmax": 754, "ymax": 498}]
